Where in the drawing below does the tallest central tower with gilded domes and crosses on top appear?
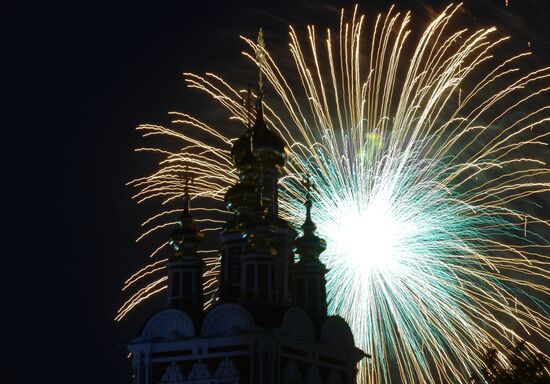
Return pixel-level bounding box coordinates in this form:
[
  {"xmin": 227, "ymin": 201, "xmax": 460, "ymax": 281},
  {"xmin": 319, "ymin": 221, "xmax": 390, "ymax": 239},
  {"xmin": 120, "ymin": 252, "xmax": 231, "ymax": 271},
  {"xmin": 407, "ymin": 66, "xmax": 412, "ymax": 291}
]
[{"xmin": 220, "ymin": 29, "xmax": 295, "ymax": 304}]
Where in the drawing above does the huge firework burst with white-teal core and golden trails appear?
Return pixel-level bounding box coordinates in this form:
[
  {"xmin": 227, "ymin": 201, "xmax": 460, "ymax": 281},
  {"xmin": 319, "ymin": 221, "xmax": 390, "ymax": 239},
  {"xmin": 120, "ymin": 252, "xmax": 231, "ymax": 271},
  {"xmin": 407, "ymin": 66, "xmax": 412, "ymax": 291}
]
[{"xmin": 117, "ymin": 6, "xmax": 550, "ymax": 383}]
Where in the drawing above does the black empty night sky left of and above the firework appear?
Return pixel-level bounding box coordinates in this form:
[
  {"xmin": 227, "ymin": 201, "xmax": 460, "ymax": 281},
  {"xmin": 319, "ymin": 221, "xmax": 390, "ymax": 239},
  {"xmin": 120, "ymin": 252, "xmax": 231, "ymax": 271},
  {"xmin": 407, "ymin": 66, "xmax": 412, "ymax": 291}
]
[{"xmin": 0, "ymin": 0, "xmax": 550, "ymax": 384}]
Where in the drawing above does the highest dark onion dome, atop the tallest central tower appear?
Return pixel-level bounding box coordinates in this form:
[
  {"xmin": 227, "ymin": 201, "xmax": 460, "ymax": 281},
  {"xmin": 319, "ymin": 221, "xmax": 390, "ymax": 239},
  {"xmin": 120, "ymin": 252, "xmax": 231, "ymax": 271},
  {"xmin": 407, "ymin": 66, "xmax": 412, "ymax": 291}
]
[{"xmin": 252, "ymin": 99, "xmax": 288, "ymax": 167}]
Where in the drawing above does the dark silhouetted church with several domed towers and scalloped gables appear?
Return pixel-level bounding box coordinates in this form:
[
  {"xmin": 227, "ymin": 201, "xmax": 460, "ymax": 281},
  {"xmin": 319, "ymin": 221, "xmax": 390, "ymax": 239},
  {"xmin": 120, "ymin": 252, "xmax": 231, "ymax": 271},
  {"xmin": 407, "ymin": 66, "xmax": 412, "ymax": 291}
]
[{"xmin": 127, "ymin": 82, "xmax": 366, "ymax": 384}]
